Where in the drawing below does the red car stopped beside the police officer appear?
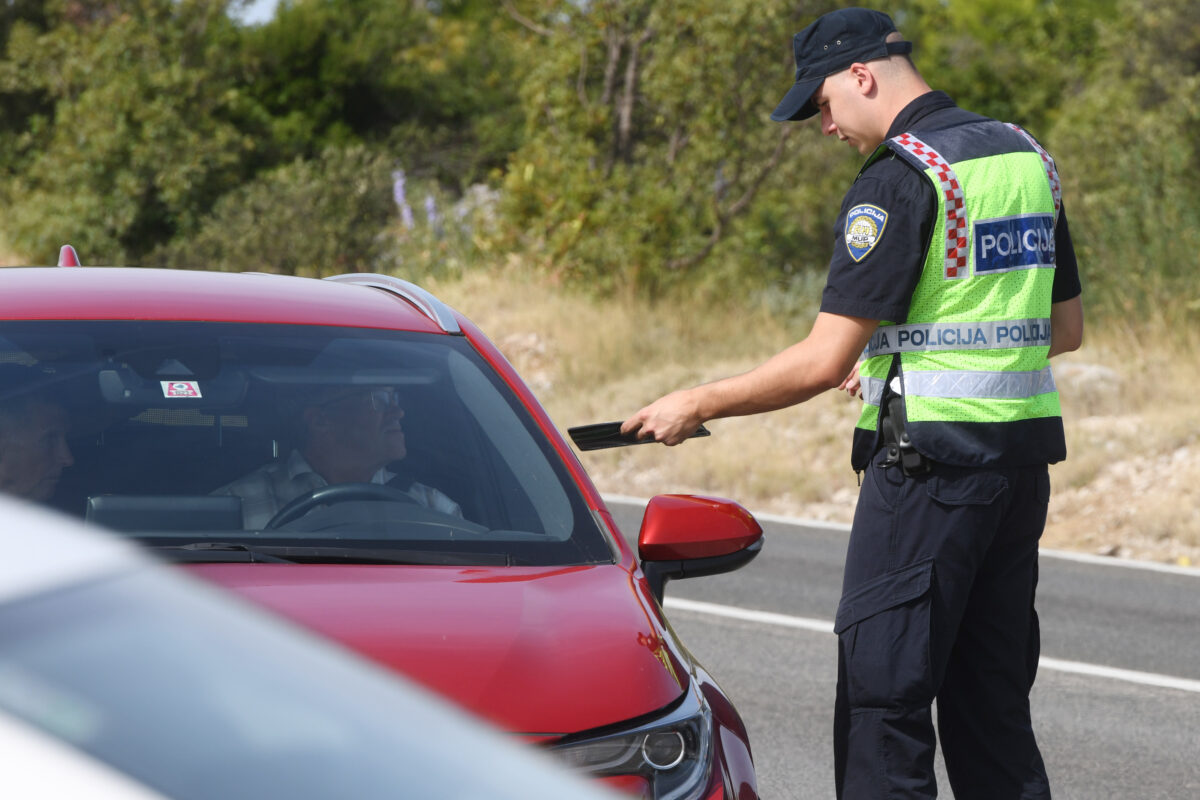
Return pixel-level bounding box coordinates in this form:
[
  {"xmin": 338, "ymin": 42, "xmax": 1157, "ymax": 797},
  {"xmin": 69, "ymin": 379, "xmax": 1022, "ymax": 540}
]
[{"xmin": 0, "ymin": 266, "xmax": 762, "ymax": 800}]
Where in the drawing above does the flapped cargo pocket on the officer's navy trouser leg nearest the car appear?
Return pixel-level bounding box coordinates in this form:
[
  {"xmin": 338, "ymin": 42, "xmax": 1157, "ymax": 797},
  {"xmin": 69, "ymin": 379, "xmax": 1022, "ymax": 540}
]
[{"xmin": 834, "ymin": 559, "xmax": 934, "ymax": 710}]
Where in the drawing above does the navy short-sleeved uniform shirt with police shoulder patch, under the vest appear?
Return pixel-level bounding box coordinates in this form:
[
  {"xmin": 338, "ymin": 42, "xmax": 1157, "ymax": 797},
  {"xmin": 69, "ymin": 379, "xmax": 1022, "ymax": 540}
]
[{"xmin": 821, "ymin": 91, "xmax": 1080, "ymax": 323}]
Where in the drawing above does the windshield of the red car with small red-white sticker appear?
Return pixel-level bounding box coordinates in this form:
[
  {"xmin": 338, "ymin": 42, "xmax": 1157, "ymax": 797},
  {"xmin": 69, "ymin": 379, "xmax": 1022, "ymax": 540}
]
[{"xmin": 0, "ymin": 320, "xmax": 613, "ymax": 565}]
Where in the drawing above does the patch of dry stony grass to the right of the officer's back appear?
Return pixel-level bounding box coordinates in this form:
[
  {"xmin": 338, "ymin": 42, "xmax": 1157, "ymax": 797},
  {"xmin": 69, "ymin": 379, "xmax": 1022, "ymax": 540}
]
[{"xmin": 1045, "ymin": 321, "xmax": 1200, "ymax": 564}]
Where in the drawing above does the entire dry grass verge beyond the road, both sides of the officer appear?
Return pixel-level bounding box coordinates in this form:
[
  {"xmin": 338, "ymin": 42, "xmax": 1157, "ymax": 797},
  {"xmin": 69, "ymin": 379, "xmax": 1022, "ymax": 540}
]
[{"xmin": 430, "ymin": 266, "xmax": 1200, "ymax": 564}]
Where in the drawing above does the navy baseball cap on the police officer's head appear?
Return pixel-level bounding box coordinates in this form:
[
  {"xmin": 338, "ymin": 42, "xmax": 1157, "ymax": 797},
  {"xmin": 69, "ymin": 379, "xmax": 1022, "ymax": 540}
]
[{"xmin": 770, "ymin": 8, "xmax": 912, "ymax": 122}]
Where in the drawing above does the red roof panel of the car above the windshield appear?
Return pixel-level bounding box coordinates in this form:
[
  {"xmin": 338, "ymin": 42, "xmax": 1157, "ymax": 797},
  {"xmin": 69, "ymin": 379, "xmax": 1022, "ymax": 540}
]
[{"xmin": 0, "ymin": 267, "xmax": 451, "ymax": 332}]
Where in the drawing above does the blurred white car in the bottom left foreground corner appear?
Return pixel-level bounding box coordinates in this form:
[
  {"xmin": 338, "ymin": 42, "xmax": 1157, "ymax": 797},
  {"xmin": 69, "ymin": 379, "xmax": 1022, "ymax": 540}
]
[{"xmin": 0, "ymin": 497, "xmax": 612, "ymax": 800}]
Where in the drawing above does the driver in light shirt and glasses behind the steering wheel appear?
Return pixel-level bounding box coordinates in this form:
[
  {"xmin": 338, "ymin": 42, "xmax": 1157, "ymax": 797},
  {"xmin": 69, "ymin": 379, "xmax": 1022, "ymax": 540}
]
[{"xmin": 214, "ymin": 386, "xmax": 462, "ymax": 530}]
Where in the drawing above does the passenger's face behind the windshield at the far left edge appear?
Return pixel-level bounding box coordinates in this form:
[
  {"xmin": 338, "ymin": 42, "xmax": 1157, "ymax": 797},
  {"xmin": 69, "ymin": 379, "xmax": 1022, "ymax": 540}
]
[{"xmin": 0, "ymin": 363, "xmax": 74, "ymax": 501}]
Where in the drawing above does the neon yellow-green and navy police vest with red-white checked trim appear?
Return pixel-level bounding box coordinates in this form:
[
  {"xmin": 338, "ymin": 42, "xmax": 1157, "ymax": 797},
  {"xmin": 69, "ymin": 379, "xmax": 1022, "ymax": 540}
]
[{"xmin": 853, "ymin": 120, "xmax": 1067, "ymax": 469}]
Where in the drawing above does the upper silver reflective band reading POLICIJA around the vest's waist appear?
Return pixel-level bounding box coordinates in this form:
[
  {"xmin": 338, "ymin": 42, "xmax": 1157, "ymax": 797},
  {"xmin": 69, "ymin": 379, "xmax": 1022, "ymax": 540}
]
[{"xmin": 864, "ymin": 319, "xmax": 1050, "ymax": 357}]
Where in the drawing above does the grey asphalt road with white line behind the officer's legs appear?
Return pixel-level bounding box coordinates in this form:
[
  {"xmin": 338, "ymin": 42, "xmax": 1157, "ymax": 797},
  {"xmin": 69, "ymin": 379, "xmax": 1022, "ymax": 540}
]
[{"xmin": 608, "ymin": 498, "xmax": 1200, "ymax": 800}]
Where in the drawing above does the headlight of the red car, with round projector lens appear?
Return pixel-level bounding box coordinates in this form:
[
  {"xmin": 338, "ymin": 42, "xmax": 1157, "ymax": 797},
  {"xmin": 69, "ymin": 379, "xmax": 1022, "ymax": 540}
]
[{"xmin": 551, "ymin": 690, "xmax": 713, "ymax": 800}]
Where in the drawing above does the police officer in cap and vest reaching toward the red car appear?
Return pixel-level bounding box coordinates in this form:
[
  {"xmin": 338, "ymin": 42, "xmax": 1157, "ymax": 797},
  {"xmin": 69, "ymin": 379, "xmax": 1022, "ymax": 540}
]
[{"xmin": 623, "ymin": 8, "xmax": 1084, "ymax": 800}]
